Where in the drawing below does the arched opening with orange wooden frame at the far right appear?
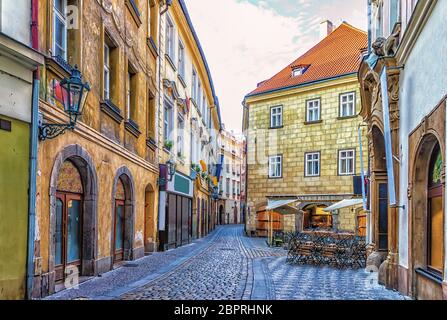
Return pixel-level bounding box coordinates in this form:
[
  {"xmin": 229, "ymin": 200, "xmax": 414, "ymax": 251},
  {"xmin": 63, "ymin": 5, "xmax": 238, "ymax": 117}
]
[{"xmin": 411, "ymin": 134, "xmax": 445, "ymax": 299}]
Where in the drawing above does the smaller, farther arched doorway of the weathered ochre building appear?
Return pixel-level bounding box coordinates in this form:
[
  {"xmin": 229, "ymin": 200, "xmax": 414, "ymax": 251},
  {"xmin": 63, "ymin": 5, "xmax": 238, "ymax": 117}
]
[{"xmin": 111, "ymin": 167, "xmax": 135, "ymax": 264}]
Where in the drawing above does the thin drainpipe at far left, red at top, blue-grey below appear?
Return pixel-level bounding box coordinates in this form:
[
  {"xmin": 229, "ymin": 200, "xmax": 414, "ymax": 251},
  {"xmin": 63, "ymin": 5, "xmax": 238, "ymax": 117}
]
[{"xmin": 26, "ymin": 0, "xmax": 40, "ymax": 300}]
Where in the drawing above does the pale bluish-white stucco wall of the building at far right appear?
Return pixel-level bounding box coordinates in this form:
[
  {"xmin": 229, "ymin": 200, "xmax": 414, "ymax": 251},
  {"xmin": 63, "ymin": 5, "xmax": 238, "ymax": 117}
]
[{"xmin": 399, "ymin": 1, "xmax": 447, "ymax": 276}]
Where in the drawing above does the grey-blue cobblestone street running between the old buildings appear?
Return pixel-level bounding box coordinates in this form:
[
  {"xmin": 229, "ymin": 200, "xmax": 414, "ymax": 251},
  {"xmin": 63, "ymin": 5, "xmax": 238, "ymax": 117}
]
[{"xmin": 48, "ymin": 226, "xmax": 405, "ymax": 300}]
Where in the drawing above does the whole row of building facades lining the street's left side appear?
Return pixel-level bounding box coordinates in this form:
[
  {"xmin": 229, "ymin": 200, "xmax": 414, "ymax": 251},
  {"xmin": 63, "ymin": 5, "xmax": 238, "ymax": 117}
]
[{"xmin": 0, "ymin": 0, "xmax": 245, "ymax": 299}]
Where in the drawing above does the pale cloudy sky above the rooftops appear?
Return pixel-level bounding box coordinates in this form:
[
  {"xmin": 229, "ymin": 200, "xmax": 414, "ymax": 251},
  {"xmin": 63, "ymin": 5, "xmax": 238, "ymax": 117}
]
[{"xmin": 185, "ymin": 0, "xmax": 367, "ymax": 132}]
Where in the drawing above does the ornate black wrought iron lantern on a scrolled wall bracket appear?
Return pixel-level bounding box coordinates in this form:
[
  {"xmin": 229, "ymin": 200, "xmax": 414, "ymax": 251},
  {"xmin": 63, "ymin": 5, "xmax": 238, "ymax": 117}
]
[{"xmin": 39, "ymin": 66, "xmax": 90, "ymax": 141}]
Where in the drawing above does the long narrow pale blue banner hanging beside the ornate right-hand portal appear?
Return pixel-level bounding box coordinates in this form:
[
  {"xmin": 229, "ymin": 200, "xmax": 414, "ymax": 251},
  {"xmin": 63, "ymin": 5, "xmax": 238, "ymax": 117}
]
[{"xmin": 380, "ymin": 67, "xmax": 397, "ymax": 206}]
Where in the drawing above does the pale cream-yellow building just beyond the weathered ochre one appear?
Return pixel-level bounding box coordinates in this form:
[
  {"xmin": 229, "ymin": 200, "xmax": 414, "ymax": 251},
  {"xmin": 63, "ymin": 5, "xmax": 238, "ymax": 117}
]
[{"xmin": 157, "ymin": 0, "xmax": 221, "ymax": 250}]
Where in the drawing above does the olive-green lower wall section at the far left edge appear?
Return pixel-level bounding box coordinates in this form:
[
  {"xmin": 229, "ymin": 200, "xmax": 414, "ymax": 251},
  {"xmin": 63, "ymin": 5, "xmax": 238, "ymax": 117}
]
[{"xmin": 0, "ymin": 115, "xmax": 29, "ymax": 300}]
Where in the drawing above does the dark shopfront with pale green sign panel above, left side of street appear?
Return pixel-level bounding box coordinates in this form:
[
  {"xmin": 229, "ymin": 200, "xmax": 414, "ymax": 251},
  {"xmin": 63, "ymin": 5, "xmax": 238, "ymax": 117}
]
[{"xmin": 159, "ymin": 168, "xmax": 193, "ymax": 251}]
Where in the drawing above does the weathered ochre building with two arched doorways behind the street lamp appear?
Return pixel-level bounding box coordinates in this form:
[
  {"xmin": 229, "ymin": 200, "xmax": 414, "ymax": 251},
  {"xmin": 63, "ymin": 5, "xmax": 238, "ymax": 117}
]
[{"xmin": 34, "ymin": 0, "xmax": 163, "ymax": 297}]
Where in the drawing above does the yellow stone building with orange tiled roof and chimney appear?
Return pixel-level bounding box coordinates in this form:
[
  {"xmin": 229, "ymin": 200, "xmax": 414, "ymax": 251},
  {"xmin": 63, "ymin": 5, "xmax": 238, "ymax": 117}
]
[{"xmin": 243, "ymin": 21, "xmax": 368, "ymax": 236}]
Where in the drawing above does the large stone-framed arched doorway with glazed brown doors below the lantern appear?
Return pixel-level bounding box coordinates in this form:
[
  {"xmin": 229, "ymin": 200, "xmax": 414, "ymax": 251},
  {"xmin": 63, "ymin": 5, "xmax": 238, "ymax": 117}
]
[{"xmin": 48, "ymin": 145, "xmax": 98, "ymax": 293}]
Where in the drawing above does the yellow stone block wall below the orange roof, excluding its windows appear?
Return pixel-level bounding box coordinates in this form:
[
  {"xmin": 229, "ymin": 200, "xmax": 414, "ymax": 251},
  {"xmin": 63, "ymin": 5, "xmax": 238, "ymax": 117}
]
[{"xmin": 246, "ymin": 76, "xmax": 368, "ymax": 230}]
